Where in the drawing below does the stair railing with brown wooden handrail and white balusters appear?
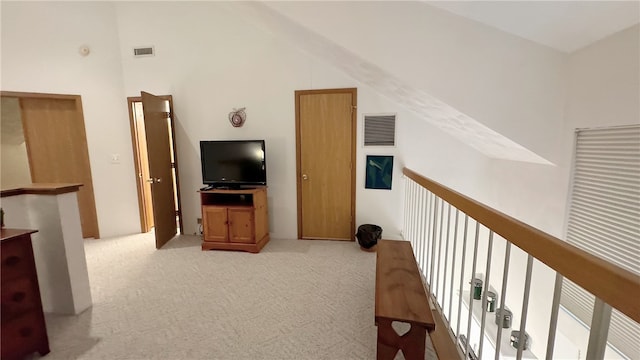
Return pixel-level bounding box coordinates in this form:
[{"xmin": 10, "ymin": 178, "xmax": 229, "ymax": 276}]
[{"xmin": 403, "ymin": 168, "xmax": 640, "ymax": 359}]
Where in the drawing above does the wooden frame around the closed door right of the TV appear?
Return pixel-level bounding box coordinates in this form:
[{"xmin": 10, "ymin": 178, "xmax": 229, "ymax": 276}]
[{"xmin": 295, "ymin": 88, "xmax": 358, "ymax": 241}]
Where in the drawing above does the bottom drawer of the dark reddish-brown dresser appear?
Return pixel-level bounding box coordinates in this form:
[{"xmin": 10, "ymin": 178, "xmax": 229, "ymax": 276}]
[{"xmin": 1, "ymin": 311, "xmax": 49, "ymax": 359}]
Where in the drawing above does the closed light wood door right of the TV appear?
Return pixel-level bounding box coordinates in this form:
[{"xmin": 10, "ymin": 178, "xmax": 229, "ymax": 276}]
[{"xmin": 296, "ymin": 89, "xmax": 357, "ymax": 240}]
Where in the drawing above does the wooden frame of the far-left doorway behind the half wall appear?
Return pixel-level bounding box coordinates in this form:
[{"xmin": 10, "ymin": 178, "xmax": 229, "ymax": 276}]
[{"xmin": 0, "ymin": 91, "xmax": 100, "ymax": 239}]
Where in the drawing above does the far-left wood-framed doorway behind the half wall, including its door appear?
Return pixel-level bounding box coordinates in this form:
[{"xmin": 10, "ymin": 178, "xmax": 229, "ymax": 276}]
[{"xmin": 0, "ymin": 91, "xmax": 100, "ymax": 239}]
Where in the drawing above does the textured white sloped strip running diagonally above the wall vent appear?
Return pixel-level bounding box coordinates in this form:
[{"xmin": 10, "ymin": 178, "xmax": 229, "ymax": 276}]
[{"xmin": 234, "ymin": 2, "xmax": 551, "ymax": 164}]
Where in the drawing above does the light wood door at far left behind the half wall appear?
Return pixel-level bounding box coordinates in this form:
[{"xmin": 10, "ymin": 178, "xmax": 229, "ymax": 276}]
[{"xmin": 19, "ymin": 94, "xmax": 100, "ymax": 239}]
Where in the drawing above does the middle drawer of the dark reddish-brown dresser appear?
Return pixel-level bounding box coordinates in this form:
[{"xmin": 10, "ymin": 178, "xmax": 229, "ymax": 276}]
[{"xmin": 0, "ymin": 277, "xmax": 40, "ymax": 324}]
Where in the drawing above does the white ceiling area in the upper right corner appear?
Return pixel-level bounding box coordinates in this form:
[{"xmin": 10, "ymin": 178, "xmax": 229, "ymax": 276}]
[{"xmin": 426, "ymin": 1, "xmax": 640, "ymax": 53}]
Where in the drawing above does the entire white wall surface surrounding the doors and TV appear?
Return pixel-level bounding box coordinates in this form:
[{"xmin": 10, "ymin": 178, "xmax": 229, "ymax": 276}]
[{"xmin": 1, "ymin": 2, "xmax": 410, "ymax": 242}]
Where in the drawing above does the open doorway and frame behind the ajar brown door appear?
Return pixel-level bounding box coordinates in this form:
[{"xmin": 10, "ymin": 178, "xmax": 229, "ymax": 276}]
[{"xmin": 127, "ymin": 95, "xmax": 184, "ymax": 238}]
